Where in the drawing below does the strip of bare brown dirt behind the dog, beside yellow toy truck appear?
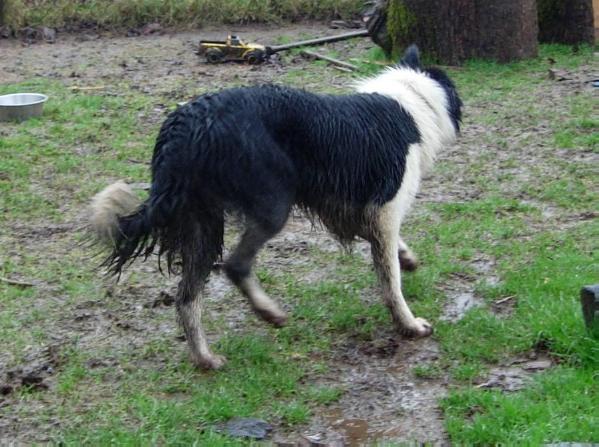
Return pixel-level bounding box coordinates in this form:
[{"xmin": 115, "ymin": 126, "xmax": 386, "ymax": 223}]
[{"xmin": 0, "ymin": 24, "xmax": 356, "ymax": 97}]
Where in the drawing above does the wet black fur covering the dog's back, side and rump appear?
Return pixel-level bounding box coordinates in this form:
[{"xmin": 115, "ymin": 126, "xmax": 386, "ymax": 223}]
[{"xmin": 109, "ymin": 86, "xmax": 420, "ymax": 272}]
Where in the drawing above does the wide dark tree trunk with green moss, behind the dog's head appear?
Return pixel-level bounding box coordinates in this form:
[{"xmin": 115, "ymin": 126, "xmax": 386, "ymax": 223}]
[{"xmin": 376, "ymin": 0, "xmax": 538, "ymax": 64}]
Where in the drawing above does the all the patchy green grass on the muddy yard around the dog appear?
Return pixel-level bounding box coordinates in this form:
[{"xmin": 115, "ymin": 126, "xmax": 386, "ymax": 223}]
[{"xmin": 0, "ymin": 43, "xmax": 599, "ymax": 446}]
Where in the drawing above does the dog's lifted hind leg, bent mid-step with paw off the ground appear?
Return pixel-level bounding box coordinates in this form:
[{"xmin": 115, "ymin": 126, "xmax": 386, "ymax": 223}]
[{"xmin": 225, "ymin": 219, "xmax": 287, "ymax": 327}]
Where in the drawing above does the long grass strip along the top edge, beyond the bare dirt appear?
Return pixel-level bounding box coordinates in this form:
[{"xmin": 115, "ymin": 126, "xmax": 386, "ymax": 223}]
[{"xmin": 6, "ymin": 0, "xmax": 363, "ymax": 29}]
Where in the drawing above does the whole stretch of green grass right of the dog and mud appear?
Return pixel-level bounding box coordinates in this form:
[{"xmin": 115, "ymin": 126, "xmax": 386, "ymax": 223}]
[{"xmin": 422, "ymin": 46, "xmax": 599, "ymax": 445}]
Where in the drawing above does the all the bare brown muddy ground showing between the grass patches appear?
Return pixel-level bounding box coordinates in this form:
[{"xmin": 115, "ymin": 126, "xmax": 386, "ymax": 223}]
[{"xmin": 0, "ymin": 24, "xmax": 590, "ymax": 445}]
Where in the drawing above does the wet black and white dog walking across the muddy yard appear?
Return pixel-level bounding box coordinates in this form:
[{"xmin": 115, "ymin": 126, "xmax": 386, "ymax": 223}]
[{"xmin": 90, "ymin": 47, "xmax": 462, "ymax": 368}]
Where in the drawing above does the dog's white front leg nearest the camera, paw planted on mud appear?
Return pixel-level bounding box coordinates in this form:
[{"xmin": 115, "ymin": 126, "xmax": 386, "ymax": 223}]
[{"xmin": 369, "ymin": 198, "xmax": 432, "ymax": 337}]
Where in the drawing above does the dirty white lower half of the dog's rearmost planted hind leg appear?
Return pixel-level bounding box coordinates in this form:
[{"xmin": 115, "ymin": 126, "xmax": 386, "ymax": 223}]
[{"xmin": 177, "ymin": 267, "xmax": 226, "ymax": 369}]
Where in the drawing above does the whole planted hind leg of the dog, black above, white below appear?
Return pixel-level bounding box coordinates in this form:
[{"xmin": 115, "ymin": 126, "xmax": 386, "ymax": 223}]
[{"xmin": 176, "ymin": 222, "xmax": 226, "ymax": 369}]
